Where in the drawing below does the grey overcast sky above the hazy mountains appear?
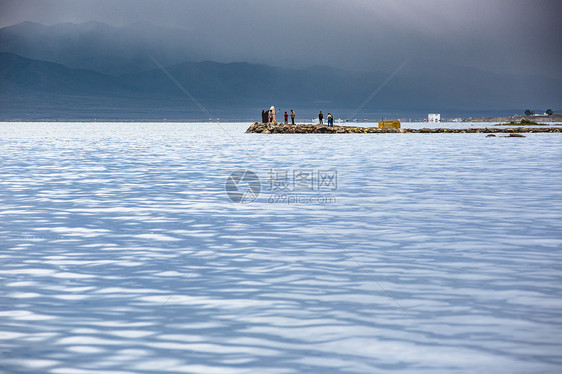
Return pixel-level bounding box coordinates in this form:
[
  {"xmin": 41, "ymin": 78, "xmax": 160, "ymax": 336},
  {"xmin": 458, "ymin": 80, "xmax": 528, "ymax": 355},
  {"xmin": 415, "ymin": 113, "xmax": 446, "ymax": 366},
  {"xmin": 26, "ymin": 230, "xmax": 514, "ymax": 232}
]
[{"xmin": 0, "ymin": 0, "xmax": 562, "ymax": 78}]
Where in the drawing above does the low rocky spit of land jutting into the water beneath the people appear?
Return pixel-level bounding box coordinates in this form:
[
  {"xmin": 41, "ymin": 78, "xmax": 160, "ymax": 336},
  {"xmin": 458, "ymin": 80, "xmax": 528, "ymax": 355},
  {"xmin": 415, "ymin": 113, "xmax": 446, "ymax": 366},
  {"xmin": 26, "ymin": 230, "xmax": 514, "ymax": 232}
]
[{"xmin": 246, "ymin": 122, "xmax": 562, "ymax": 134}]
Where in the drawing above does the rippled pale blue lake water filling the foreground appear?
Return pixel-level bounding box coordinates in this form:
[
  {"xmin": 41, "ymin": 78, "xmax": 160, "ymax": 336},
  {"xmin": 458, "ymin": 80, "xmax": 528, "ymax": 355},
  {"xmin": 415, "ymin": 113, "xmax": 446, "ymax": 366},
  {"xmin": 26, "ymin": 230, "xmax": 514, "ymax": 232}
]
[{"xmin": 0, "ymin": 123, "xmax": 562, "ymax": 374}]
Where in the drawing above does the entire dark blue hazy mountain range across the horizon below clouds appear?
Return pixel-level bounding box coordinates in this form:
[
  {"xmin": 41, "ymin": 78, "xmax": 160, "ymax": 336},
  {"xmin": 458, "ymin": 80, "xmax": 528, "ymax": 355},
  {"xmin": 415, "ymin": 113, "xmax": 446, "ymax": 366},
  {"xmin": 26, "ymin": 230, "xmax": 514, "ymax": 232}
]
[{"xmin": 0, "ymin": 22, "xmax": 562, "ymax": 119}]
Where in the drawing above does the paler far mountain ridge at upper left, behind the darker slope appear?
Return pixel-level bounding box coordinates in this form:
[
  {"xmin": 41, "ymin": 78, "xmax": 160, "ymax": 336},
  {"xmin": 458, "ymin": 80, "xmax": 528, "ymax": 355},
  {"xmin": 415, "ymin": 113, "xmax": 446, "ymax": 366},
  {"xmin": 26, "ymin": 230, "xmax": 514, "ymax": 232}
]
[{"xmin": 0, "ymin": 22, "xmax": 199, "ymax": 75}]
